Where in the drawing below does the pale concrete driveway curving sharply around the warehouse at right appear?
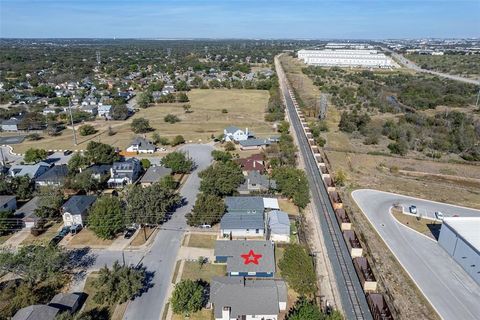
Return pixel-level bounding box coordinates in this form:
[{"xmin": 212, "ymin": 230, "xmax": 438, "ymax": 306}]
[{"xmin": 352, "ymin": 189, "xmax": 480, "ymax": 320}]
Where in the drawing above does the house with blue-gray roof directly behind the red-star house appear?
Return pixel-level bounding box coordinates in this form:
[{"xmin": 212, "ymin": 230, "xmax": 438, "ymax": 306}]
[{"xmin": 220, "ymin": 197, "xmax": 265, "ymax": 238}]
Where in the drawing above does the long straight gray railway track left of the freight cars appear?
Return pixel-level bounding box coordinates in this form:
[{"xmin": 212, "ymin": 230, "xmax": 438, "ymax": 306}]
[{"xmin": 275, "ymin": 57, "xmax": 372, "ymax": 319}]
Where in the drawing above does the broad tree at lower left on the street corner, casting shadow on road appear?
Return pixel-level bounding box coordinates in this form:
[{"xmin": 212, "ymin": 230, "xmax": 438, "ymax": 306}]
[{"xmin": 93, "ymin": 261, "xmax": 146, "ymax": 305}]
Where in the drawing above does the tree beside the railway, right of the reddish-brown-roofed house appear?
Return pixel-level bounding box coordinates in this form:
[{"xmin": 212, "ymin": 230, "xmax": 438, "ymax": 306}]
[{"xmin": 272, "ymin": 167, "xmax": 310, "ymax": 208}]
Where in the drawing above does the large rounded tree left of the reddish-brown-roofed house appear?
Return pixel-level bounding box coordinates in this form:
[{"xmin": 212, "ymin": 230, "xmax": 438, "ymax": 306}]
[{"xmin": 198, "ymin": 161, "xmax": 245, "ymax": 197}]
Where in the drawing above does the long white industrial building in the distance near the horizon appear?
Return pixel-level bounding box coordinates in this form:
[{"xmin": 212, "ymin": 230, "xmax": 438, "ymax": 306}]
[{"xmin": 298, "ymin": 49, "xmax": 396, "ymax": 68}]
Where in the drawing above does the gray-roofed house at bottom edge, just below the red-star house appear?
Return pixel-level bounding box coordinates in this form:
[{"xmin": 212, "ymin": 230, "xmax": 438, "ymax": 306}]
[{"xmin": 209, "ymin": 277, "xmax": 287, "ymax": 320}]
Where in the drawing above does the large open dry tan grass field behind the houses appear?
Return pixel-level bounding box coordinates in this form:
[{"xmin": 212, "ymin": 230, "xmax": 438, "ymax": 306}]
[{"xmin": 6, "ymin": 89, "xmax": 274, "ymax": 153}]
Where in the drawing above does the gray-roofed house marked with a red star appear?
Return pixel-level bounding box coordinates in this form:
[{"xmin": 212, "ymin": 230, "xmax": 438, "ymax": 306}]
[{"xmin": 214, "ymin": 240, "xmax": 275, "ymax": 278}]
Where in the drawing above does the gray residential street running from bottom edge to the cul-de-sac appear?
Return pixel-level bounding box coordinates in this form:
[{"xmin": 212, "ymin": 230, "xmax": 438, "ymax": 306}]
[{"xmin": 124, "ymin": 145, "xmax": 213, "ymax": 320}]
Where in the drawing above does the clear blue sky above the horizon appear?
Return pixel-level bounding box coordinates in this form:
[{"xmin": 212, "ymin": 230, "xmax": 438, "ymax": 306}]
[{"xmin": 0, "ymin": 0, "xmax": 480, "ymax": 39}]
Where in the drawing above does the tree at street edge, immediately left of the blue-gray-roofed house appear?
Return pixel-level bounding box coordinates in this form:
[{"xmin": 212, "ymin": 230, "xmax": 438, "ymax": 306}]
[{"xmin": 187, "ymin": 193, "xmax": 225, "ymax": 226}]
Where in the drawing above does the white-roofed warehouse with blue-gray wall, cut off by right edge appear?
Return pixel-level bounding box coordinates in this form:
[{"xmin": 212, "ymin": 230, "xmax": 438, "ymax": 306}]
[{"xmin": 438, "ymin": 217, "xmax": 480, "ymax": 285}]
